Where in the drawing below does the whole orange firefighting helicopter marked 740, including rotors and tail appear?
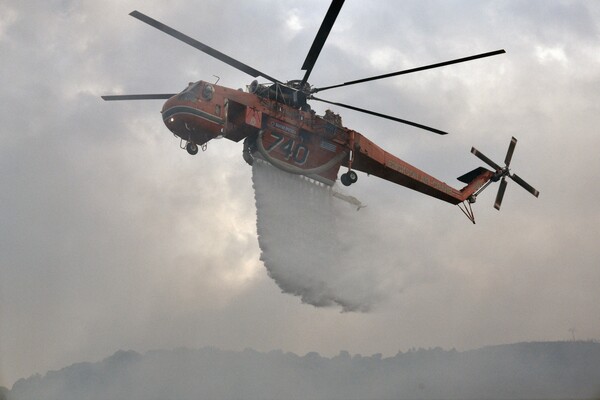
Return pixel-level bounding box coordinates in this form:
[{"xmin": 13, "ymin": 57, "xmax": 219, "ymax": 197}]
[{"xmin": 102, "ymin": 0, "xmax": 539, "ymax": 223}]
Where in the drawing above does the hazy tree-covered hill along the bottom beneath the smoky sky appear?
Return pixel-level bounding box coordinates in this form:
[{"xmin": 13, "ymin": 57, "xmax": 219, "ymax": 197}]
[{"xmin": 5, "ymin": 342, "xmax": 600, "ymax": 400}]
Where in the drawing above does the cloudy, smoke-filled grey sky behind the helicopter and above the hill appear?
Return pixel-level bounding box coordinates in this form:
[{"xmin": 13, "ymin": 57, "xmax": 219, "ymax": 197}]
[{"xmin": 0, "ymin": 0, "xmax": 600, "ymax": 386}]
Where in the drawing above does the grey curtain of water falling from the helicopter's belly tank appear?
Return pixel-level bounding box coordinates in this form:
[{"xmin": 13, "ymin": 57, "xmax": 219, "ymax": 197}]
[{"xmin": 252, "ymin": 160, "xmax": 402, "ymax": 312}]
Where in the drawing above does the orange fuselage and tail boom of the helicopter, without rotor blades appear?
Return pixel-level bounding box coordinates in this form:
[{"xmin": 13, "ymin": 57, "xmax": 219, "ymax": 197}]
[{"xmin": 161, "ymin": 81, "xmax": 493, "ymax": 204}]
